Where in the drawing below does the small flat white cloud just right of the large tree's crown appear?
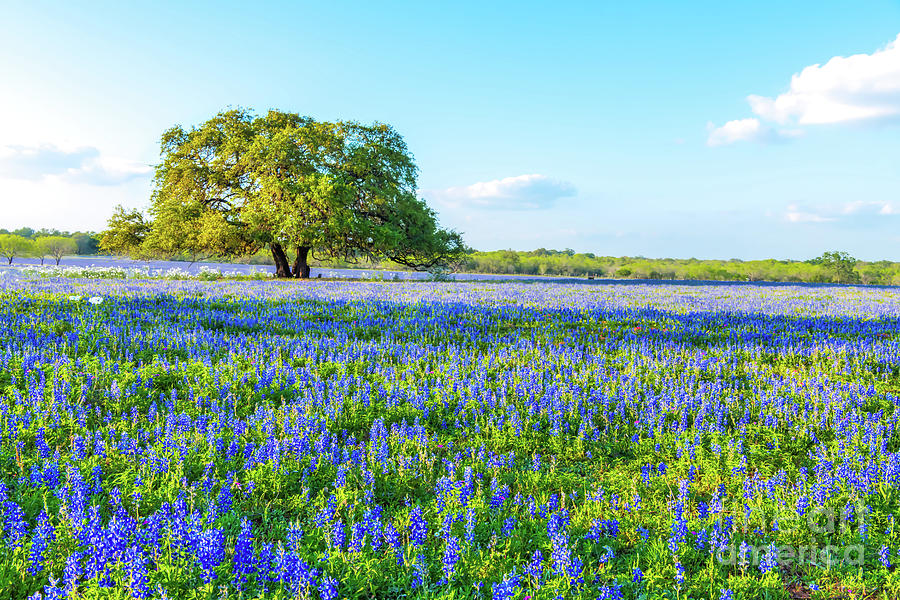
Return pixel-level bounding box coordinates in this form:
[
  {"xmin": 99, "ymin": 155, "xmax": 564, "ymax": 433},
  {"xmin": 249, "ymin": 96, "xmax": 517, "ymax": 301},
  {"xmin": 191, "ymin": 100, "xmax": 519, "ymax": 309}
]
[{"xmin": 423, "ymin": 174, "xmax": 575, "ymax": 209}]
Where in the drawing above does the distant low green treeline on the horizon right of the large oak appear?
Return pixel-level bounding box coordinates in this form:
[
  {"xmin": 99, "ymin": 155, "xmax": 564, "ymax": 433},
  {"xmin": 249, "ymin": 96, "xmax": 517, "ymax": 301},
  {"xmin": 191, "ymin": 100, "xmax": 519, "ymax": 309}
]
[{"xmin": 462, "ymin": 248, "xmax": 900, "ymax": 285}]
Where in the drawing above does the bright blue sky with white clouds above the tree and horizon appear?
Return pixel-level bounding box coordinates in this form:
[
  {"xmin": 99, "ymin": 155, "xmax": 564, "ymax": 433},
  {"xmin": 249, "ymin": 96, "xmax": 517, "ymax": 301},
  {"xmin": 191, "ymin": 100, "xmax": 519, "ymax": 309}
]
[{"xmin": 0, "ymin": 0, "xmax": 900, "ymax": 260}]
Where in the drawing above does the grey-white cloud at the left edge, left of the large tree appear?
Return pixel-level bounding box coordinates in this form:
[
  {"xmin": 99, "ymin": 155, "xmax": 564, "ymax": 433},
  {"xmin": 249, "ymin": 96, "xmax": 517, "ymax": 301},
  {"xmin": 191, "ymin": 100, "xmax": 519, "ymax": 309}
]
[{"xmin": 0, "ymin": 144, "xmax": 153, "ymax": 185}]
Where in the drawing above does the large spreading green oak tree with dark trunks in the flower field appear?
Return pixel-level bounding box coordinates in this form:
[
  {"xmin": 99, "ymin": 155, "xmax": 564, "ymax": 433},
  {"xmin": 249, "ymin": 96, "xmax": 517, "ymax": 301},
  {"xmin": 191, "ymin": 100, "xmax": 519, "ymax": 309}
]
[{"xmin": 101, "ymin": 110, "xmax": 465, "ymax": 277}]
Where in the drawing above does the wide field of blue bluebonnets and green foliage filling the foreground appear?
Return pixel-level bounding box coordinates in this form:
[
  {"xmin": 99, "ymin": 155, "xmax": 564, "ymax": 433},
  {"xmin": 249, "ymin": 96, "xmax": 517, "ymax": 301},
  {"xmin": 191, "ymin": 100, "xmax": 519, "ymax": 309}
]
[{"xmin": 0, "ymin": 279, "xmax": 900, "ymax": 600}]
